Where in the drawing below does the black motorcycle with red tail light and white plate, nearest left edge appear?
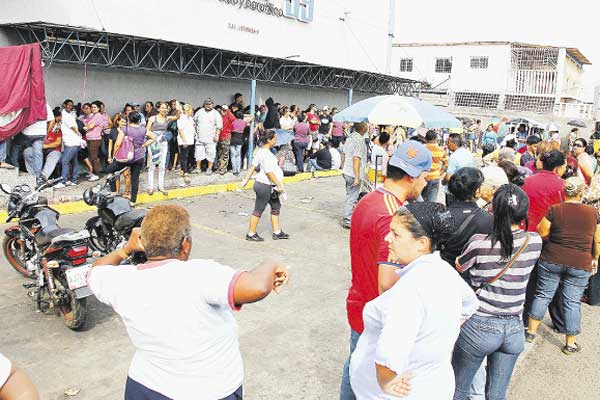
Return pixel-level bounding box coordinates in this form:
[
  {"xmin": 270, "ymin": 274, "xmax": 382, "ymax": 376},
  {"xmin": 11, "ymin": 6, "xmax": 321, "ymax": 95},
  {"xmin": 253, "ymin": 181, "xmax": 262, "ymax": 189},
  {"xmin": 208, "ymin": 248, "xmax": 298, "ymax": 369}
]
[{"xmin": 0, "ymin": 179, "xmax": 92, "ymax": 330}]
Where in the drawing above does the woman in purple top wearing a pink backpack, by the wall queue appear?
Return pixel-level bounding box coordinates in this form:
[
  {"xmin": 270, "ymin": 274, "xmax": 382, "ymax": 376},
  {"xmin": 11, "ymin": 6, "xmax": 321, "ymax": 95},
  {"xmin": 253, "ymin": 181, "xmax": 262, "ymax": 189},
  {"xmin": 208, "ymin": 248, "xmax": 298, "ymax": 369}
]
[{"xmin": 106, "ymin": 111, "xmax": 154, "ymax": 203}]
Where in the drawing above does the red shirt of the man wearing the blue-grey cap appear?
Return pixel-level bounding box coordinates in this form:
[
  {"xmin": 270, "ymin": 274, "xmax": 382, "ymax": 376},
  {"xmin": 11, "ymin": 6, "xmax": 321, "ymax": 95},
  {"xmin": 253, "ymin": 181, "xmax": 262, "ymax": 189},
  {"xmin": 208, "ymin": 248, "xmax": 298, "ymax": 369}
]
[{"xmin": 346, "ymin": 188, "xmax": 402, "ymax": 333}]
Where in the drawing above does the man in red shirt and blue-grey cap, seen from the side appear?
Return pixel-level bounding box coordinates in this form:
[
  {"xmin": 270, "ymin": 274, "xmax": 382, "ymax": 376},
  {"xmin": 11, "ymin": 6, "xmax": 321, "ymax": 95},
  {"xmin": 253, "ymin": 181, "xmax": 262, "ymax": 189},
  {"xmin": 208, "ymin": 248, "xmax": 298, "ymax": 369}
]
[{"xmin": 340, "ymin": 140, "xmax": 432, "ymax": 400}]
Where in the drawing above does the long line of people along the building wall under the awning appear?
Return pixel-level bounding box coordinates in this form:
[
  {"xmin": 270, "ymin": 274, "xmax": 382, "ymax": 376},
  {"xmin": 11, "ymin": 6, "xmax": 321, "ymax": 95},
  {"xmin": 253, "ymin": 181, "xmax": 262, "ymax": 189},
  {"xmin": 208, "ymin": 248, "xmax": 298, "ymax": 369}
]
[{"xmin": 0, "ymin": 93, "xmax": 347, "ymax": 202}]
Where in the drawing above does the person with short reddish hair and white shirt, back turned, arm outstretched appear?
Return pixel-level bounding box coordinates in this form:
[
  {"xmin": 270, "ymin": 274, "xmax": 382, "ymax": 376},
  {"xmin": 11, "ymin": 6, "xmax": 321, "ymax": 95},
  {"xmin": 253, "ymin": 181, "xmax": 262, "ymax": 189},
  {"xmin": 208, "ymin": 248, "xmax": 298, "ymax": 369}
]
[{"xmin": 87, "ymin": 205, "xmax": 287, "ymax": 400}]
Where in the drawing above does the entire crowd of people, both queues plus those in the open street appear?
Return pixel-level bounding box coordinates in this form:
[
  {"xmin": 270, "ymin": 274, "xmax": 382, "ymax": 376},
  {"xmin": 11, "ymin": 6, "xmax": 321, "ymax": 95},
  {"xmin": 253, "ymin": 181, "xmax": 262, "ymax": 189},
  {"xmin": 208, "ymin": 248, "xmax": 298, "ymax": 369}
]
[{"xmin": 0, "ymin": 95, "xmax": 600, "ymax": 400}]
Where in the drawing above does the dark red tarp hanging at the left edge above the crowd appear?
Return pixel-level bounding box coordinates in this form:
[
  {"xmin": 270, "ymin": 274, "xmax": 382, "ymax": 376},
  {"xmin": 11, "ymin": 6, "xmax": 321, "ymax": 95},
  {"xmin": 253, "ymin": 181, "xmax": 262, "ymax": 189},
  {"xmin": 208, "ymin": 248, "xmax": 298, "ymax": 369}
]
[{"xmin": 0, "ymin": 43, "xmax": 47, "ymax": 142}]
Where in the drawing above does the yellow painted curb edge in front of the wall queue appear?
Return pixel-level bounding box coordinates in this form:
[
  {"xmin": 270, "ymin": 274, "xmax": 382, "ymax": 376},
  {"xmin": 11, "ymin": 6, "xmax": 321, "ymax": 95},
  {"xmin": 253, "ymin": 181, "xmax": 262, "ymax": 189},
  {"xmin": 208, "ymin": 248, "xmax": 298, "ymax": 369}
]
[{"xmin": 0, "ymin": 171, "xmax": 342, "ymax": 223}]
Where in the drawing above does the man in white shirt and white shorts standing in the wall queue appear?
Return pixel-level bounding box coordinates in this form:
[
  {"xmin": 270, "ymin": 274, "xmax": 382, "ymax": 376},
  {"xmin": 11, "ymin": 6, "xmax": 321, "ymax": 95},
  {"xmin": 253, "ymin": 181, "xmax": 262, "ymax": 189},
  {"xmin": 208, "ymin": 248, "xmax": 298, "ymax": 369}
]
[{"xmin": 194, "ymin": 99, "xmax": 223, "ymax": 175}]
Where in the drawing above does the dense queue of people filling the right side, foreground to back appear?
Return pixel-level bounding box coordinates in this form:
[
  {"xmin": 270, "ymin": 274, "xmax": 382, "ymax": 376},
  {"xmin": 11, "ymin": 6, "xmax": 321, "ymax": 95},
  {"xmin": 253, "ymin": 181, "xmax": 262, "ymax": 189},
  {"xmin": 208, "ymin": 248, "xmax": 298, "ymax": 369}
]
[{"xmin": 340, "ymin": 124, "xmax": 600, "ymax": 400}]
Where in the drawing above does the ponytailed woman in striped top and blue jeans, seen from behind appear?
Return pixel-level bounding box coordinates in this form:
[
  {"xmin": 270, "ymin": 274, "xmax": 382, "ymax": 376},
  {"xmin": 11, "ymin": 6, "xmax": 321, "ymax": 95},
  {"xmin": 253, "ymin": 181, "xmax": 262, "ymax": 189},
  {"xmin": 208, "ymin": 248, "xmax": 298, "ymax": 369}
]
[{"xmin": 452, "ymin": 183, "xmax": 542, "ymax": 400}]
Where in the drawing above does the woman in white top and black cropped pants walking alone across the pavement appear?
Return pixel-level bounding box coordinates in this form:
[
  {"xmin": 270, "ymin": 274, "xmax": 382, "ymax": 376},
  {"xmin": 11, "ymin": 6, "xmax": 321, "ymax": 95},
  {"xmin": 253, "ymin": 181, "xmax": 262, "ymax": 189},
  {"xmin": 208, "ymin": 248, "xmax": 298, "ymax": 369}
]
[{"xmin": 240, "ymin": 129, "xmax": 290, "ymax": 242}]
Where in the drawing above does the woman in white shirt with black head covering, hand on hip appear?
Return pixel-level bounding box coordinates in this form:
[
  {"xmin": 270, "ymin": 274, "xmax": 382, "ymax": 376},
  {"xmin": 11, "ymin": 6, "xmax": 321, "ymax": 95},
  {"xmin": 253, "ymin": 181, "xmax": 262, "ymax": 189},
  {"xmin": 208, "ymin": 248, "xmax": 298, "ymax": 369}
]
[{"xmin": 350, "ymin": 202, "xmax": 479, "ymax": 400}]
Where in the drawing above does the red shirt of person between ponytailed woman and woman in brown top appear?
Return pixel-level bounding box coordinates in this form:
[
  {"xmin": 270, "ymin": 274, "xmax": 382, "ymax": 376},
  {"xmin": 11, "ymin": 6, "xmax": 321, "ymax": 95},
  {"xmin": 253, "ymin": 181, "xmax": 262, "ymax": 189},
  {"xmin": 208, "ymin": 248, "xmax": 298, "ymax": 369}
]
[{"xmin": 521, "ymin": 170, "xmax": 566, "ymax": 232}]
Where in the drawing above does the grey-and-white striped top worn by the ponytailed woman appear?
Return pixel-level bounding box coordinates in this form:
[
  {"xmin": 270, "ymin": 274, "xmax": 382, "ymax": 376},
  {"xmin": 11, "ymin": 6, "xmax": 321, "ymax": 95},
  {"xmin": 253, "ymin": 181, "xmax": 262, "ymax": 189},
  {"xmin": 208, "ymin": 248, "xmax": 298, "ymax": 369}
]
[{"xmin": 456, "ymin": 229, "xmax": 542, "ymax": 316}]
